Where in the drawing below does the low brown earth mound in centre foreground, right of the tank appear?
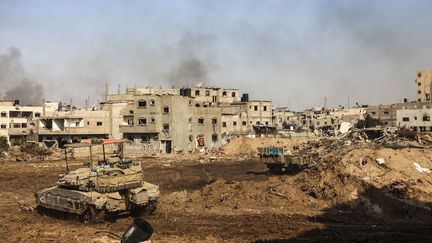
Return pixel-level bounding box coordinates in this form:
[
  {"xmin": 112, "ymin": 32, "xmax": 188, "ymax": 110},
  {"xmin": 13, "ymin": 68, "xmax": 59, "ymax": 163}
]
[{"xmin": 159, "ymin": 177, "xmax": 328, "ymax": 214}]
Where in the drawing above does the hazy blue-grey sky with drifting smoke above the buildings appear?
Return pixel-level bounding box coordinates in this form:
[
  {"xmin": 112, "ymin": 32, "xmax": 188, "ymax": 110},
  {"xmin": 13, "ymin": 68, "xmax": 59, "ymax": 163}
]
[{"xmin": 0, "ymin": 0, "xmax": 432, "ymax": 110}]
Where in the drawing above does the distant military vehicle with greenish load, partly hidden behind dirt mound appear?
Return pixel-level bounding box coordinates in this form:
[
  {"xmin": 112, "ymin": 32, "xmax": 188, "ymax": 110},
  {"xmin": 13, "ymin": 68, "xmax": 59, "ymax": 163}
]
[{"xmin": 258, "ymin": 146, "xmax": 318, "ymax": 174}]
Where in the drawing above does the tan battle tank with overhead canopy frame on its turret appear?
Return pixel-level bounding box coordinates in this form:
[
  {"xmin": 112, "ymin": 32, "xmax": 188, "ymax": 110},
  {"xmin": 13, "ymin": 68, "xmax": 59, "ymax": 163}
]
[{"xmin": 35, "ymin": 140, "xmax": 159, "ymax": 222}]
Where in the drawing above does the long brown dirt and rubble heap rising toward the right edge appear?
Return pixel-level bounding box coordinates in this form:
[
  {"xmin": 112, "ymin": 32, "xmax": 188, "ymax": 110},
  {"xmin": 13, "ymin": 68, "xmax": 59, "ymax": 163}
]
[{"xmin": 161, "ymin": 131, "xmax": 432, "ymax": 222}]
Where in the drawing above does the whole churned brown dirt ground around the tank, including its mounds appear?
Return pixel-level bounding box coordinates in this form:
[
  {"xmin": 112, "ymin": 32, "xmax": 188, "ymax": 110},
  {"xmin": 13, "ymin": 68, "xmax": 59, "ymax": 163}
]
[{"xmin": 0, "ymin": 137, "xmax": 432, "ymax": 242}]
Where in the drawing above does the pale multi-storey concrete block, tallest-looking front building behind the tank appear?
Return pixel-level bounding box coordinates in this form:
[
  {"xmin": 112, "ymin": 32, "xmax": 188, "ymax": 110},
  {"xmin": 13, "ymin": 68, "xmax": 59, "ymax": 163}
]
[{"xmin": 110, "ymin": 94, "xmax": 221, "ymax": 153}]
